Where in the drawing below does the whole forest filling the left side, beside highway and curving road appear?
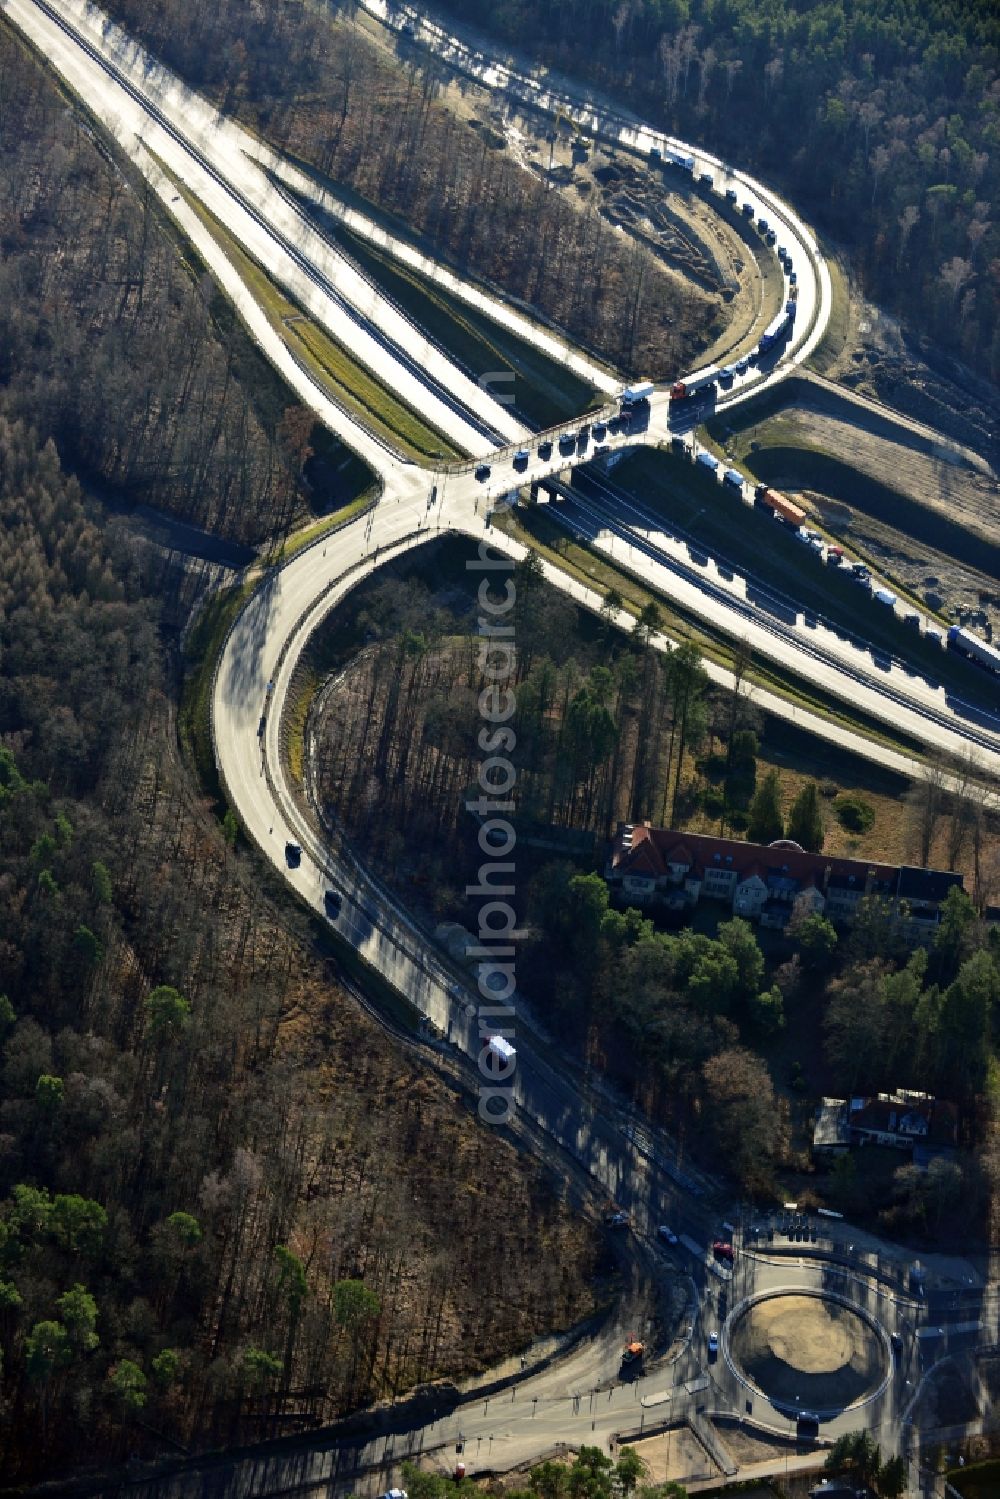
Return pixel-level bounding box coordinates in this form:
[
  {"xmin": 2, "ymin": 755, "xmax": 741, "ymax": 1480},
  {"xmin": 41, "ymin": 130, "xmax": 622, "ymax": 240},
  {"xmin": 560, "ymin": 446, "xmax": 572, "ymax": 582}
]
[{"xmin": 0, "ymin": 30, "xmax": 595, "ymax": 1481}]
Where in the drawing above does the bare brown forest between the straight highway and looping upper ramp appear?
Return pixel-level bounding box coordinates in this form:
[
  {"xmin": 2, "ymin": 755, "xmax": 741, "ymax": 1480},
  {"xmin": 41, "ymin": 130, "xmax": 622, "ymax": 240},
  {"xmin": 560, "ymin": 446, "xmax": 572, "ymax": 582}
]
[{"xmin": 91, "ymin": 0, "xmax": 721, "ymax": 378}]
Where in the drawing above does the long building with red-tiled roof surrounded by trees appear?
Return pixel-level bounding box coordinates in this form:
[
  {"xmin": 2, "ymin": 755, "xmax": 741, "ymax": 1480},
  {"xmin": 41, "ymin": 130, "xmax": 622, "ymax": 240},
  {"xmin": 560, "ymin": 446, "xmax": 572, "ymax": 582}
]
[{"xmin": 604, "ymin": 823, "xmax": 963, "ymax": 947}]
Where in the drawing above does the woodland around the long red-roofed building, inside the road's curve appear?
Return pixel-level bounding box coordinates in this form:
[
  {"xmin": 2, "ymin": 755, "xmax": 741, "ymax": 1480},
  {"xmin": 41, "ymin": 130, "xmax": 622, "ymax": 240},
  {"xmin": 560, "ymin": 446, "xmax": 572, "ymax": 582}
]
[{"xmin": 312, "ymin": 543, "xmax": 1000, "ymax": 1246}]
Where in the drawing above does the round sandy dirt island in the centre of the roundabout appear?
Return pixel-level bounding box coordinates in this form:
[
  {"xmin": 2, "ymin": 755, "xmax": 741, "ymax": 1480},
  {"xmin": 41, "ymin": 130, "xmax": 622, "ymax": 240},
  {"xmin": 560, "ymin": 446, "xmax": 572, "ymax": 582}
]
[{"xmin": 730, "ymin": 1295, "xmax": 885, "ymax": 1411}]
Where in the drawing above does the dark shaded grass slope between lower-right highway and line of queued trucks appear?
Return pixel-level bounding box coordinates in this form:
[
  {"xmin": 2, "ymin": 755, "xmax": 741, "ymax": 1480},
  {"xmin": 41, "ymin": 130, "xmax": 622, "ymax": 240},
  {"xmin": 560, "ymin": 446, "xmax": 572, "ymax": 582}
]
[{"xmin": 615, "ymin": 448, "xmax": 1000, "ymax": 702}]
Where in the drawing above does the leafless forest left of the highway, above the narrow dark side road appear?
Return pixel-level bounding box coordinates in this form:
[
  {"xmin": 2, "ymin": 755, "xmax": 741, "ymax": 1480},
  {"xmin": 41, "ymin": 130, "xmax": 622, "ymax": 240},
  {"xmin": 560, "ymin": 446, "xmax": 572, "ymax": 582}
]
[{"xmin": 0, "ymin": 30, "xmax": 316, "ymax": 541}]
